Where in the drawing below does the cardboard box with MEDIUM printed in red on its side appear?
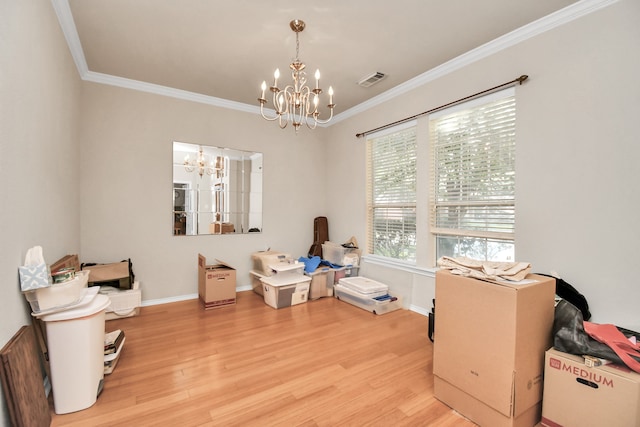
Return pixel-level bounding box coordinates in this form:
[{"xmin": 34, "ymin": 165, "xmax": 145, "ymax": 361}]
[{"xmin": 542, "ymin": 349, "xmax": 640, "ymax": 427}]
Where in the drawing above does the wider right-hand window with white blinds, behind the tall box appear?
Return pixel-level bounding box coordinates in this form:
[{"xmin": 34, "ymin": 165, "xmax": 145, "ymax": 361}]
[{"xmin": 429, "ymin": 89, "xmax": 516, "ymax": 261}]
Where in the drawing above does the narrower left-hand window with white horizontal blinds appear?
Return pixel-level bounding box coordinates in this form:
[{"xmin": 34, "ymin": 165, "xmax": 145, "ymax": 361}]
[{"xmin": 367, "ymin": 122, "xmax": 417, "ymax": 262}]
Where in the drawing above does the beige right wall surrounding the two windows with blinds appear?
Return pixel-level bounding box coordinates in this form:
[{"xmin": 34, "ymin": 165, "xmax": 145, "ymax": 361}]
[{"xmin": 327, "ymin": 0, "xmax": 640, "ymax": 330}]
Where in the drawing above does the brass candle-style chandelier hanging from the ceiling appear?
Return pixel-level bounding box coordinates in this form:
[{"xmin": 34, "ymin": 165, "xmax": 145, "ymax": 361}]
[{"xmin": 258, "ymin": 19, "xmax": 335, "ymax": 133}]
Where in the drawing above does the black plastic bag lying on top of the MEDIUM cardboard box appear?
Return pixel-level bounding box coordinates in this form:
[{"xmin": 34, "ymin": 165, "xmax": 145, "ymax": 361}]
[{"xmin": 553, "ymin": 300, "xmax": 640, "ymax": 365}]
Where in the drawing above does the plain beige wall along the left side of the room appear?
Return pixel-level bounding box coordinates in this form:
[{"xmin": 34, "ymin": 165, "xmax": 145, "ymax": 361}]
[{"xmin": 0, "ymin": 0, "xmax": 80, "ymax": 425}]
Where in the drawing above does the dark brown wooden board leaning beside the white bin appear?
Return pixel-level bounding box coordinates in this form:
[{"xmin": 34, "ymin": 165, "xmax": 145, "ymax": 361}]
[{"xmin": 0, "ymin": 326, "xmax": 51, "ymax": 427}]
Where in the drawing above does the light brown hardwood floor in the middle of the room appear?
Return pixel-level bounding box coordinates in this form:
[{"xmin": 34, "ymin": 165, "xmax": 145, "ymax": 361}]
[{"xmin": 50, "ymin": 291, "xmax": 475, "ymax": 427}]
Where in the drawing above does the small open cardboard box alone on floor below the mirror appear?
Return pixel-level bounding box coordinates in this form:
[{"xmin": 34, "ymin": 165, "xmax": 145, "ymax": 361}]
[{"xmin": 198, "ymin": 254, "xmax": 236, "ymax": 310}]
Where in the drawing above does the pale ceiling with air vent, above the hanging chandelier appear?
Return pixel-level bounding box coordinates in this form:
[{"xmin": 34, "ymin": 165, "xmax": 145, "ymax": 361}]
[{"xmin": 52, "ymin": 0, "xmax": 611, "ymax": 123}]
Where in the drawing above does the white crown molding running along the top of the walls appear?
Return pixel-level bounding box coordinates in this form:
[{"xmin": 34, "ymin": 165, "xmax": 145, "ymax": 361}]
[{"xmin": 51, "ymin": 0, "xmax": 620, "ymax": 126}]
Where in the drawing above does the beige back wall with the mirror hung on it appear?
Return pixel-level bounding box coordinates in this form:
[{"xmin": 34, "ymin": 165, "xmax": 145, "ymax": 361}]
[{"xmin": 80, "ymin": 83, "xmax": 326, "ymax": 302}]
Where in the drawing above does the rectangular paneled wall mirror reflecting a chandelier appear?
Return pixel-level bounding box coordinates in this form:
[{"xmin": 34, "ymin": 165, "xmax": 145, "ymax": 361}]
[{"xmin": 172, "ymin": 142, "xmax": 262, "ymax": 236}]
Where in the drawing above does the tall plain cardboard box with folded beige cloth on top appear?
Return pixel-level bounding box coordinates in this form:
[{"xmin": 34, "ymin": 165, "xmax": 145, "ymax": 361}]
[{"xmin": 433, "ymin": 270, "xmax": 555, "ymax": 427}]
